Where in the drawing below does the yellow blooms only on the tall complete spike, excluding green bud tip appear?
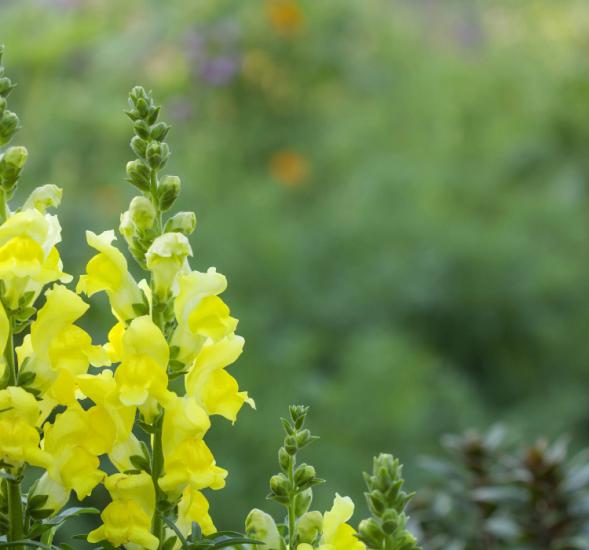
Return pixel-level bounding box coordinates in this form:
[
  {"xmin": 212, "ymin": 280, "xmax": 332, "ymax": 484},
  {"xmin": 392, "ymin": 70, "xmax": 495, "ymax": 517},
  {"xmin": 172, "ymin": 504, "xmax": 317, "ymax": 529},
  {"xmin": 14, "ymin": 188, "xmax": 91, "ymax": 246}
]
[{"xmin": 76, "ymin": 231, "xmax": 254, "ymax": 548}]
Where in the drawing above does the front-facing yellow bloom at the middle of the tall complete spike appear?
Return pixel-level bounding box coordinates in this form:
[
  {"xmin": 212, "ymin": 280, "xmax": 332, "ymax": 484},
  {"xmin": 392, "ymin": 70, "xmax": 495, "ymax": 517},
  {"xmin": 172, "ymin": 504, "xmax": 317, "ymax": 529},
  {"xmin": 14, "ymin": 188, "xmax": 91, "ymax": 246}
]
[{"xmin": 115, "ymin": 315, "xmax": 170, "ymax": 406}]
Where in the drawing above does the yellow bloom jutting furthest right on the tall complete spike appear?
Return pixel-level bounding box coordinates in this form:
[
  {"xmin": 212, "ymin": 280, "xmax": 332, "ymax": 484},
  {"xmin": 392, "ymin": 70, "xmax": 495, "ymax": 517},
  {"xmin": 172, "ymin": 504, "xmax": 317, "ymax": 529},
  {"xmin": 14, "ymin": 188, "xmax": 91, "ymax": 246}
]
[{"xmin": 185, "ymin": 334, "xmax": 255, "ymax": 422}]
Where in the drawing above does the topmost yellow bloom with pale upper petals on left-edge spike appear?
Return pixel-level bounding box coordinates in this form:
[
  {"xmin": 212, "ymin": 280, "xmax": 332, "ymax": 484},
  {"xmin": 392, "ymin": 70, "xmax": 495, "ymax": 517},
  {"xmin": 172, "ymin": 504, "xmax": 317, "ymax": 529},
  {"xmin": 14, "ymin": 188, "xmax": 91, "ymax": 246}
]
[{"xmin": 0, "ymin": 208, "xmax": 72, "ymax": 309}]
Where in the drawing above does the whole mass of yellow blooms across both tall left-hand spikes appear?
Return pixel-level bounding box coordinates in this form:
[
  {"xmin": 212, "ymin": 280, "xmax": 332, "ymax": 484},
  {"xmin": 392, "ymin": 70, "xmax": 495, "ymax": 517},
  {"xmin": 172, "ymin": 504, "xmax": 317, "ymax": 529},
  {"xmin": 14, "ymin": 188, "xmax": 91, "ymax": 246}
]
[{"xmin": 0, "ymin": 183, "xmax": 248, "ymax": 549}]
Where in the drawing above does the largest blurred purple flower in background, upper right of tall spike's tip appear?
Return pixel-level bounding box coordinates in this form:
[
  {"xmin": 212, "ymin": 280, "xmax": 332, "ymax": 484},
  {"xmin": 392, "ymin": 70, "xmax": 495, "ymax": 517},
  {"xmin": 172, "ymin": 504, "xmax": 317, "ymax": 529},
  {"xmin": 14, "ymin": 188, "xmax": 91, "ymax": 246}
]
[{"xmin": 186, "ymin": 21, "xmax": 241, "ymax": 86}]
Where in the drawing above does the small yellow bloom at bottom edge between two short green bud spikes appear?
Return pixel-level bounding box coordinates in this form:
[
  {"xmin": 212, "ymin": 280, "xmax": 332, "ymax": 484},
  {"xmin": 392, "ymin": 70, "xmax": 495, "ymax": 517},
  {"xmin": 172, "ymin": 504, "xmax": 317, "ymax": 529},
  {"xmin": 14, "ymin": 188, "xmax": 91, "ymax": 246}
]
[{"xmin": 297, "ymin": 493, "xmax": 366, "ymax": 550}]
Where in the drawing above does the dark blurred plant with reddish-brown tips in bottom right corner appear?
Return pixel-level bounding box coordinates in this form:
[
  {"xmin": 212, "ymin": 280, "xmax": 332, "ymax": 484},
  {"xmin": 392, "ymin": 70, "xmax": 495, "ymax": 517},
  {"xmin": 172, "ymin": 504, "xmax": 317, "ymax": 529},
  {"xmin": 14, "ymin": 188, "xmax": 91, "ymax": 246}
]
[{"xmin": 412, "ymin": 427, "xmax": 589, "ymax": 550}]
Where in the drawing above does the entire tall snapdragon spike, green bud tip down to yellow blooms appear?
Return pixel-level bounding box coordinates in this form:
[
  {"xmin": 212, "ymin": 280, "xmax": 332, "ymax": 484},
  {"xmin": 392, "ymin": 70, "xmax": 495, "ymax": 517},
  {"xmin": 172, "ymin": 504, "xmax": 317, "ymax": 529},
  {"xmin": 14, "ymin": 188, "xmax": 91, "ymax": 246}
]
[{"xmin": 74, "ymin": 87, "xmax": 254, "ymax": 549}]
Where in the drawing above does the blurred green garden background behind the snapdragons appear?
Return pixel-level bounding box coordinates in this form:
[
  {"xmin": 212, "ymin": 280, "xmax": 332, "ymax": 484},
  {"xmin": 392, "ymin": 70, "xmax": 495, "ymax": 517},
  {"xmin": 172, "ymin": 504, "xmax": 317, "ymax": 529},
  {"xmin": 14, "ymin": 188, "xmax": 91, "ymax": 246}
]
[{"xmin": 0, "ymin": 0, "xmax": 589, "ymax": 540}]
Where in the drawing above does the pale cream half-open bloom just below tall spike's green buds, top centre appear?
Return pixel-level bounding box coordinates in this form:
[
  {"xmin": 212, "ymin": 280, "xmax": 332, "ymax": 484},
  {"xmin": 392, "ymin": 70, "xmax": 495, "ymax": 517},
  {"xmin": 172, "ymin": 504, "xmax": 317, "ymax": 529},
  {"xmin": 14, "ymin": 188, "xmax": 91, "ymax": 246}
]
[{"xmin": 145, "ymin": 233, "xmax": 192, "ymax": 299}]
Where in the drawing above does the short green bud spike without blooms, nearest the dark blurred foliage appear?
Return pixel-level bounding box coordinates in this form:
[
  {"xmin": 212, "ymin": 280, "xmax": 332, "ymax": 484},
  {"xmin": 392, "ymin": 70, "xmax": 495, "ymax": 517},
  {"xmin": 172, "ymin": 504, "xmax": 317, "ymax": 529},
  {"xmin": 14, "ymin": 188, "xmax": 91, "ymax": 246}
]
[{"xmin": 358, "ymin": 454, "xmax": 418, "ymax": 550}]
